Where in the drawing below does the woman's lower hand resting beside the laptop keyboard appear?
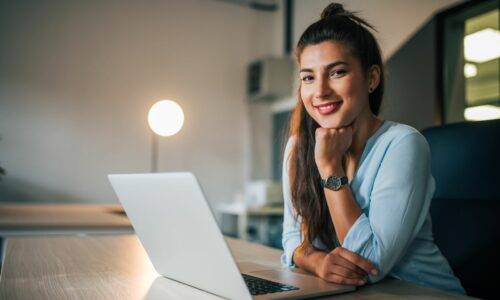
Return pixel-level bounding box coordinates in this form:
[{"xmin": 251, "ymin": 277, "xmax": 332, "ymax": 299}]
[{"xmin": 315, "ymin": 247, "xmax": 378, "ymax": 285}]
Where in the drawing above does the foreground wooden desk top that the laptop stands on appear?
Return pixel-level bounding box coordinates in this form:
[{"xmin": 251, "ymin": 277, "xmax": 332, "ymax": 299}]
[{"xmin": 0, "ymin": 235, "xmax": 472, "ymax": 299}]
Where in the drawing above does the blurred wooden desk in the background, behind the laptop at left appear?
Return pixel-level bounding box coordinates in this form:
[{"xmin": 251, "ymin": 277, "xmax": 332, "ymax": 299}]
[{"xmin": 0, "ymin": 204, "xmax": 133, "ymax": 236}]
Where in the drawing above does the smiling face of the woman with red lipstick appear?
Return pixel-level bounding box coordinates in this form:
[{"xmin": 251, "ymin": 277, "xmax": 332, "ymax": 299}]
[{"xmin": 299, "ymin": 42, "xmax": 371, "ymax": 128}]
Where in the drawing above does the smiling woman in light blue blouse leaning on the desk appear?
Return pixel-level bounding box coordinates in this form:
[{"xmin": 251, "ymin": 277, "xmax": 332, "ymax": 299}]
[{"xmin": 282, "ymin": 3, "xmax": 464, "ymax": 293}]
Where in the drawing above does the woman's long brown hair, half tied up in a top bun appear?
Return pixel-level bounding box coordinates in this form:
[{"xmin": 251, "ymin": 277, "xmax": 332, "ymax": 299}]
[{"xmin": 287, "ymin": 3, "xmax": 384, "ymax": 250}]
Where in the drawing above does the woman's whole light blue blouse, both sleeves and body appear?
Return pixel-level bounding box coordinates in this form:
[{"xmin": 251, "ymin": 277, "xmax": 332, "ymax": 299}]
[{"xmin": 281, "ymin": 121, "xmax": 465, "ymax": 294}]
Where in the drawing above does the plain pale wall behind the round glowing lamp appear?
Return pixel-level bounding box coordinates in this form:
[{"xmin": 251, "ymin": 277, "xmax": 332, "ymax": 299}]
[{"xmin": 0, "ymin": 0, "xmax": 276, "ymax": 203}]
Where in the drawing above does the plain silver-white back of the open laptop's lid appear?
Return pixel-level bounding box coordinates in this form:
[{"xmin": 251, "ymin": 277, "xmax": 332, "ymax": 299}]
[{"xmin": 108, "ymin": 172, "xmax": 251, "ymax": 299}]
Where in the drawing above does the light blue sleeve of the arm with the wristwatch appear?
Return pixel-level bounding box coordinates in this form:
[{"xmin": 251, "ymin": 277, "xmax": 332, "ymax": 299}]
[{"xmin": 342, "ymin": 132, "xmax": 434, "ymax": 282}]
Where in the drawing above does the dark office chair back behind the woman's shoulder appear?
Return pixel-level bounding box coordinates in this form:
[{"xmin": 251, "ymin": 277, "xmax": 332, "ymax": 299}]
[{"xmin": 422, "ymin": 120, "xmax": 500, "ymax": 298}]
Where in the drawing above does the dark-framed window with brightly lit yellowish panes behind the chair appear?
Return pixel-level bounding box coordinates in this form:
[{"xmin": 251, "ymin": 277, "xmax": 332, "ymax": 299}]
[{"xmin": 442, "ymin": 1, "xmax": 500, "ymax": 123}]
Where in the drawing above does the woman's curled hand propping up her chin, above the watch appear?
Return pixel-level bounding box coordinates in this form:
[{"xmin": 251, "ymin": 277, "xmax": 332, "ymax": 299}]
[{"xmin": 314, "ymin": 125, "xmax": 354, "ymax": 179}]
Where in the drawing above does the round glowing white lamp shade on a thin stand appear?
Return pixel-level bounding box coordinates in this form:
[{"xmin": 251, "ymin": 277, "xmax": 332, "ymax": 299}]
[{"xmin": 148, "ymin": 100, "xmax": 184, "ymax": 136}]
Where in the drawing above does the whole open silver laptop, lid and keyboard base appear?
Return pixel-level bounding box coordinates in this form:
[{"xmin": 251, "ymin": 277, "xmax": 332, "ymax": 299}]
[{"xmin": 108, "ymin": 172, "xmax": 355, "ymax": 299}]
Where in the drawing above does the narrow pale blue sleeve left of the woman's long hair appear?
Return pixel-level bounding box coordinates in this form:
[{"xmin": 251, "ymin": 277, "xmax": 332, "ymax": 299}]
[{"xmin": 281, "ymin": 138, "xmax": 301, "ymax": 267}]
